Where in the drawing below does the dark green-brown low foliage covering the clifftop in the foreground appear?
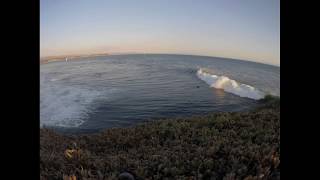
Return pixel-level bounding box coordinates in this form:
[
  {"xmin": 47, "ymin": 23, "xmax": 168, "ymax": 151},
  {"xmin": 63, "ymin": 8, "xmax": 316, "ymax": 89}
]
[{"xmin": 40, "ymin": 97, "xmax": 280, "ymax": 180}]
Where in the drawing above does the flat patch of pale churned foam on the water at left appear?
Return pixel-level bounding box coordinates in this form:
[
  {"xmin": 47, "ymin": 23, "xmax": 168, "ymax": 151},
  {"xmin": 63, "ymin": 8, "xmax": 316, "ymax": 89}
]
[{"xmin": 40, "ymin": 74, "xmax": 115, "ymax": 127}]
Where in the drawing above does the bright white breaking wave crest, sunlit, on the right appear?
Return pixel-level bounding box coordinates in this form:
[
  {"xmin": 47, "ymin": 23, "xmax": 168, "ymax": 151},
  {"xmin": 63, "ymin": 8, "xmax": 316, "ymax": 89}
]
[{"xmin": 197, "ymin": 68, "xmax": 265, "ymax": 100}]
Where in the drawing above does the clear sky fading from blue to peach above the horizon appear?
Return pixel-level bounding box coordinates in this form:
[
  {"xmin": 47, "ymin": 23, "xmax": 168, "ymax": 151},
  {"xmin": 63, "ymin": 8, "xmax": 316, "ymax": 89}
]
[{"xmin": 40, "ymin": 0, "xmax": 280, "ymax": 66}]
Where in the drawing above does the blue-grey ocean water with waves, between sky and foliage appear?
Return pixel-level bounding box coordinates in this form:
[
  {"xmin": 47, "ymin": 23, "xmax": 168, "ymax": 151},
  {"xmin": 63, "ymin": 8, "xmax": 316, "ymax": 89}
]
[{"xmin": 40, "ymin": 54, "xmax": 280, "ymax": 133}]
